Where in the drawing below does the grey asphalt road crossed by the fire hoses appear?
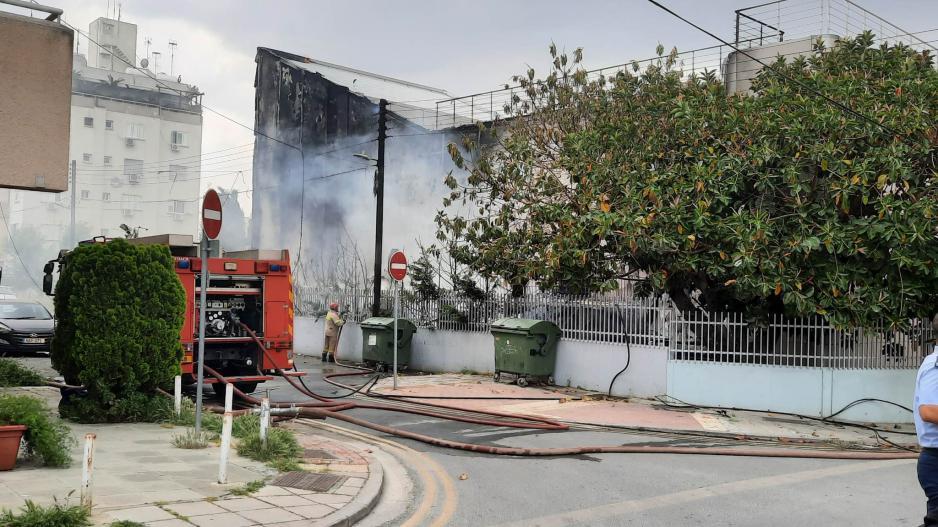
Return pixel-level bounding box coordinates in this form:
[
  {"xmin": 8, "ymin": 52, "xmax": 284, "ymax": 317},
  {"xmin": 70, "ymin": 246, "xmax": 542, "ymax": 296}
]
[{"xmin": 11, "ymin": 357, "xmax": 924, "ymax": 527}]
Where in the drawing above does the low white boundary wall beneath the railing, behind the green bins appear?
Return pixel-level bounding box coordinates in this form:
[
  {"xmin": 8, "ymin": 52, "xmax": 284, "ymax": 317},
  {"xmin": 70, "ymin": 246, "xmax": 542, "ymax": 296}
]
[{"xmin": 295, "ymin": 317, "xmax": 916, "ymax": 423}]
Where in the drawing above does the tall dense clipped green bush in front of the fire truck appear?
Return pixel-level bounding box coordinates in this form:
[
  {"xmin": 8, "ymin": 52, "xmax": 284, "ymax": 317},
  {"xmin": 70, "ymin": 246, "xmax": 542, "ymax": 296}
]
[{"xmin": 52, "ymin": 240, "xmax": 186, "ymax": 421}]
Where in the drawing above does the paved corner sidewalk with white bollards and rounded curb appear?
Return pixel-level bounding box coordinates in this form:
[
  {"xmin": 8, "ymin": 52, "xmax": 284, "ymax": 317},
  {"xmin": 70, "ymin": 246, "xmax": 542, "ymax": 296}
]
[{"xmin": 0, "ymin": 388, "xmax": 383, "ymax": 527}]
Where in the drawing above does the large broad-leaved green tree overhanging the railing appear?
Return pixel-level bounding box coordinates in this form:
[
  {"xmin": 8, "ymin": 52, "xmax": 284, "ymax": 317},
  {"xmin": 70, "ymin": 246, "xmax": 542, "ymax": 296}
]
[{"xmin": 437, "ymin": 33, "xmax": 938, "ymax": 326}]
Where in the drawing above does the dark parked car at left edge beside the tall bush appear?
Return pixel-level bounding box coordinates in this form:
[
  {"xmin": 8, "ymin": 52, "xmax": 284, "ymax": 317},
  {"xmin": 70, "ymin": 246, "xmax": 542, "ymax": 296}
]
[{"xmin": 0, "ymin": 300, "xmax": 55, "ymax": 355}]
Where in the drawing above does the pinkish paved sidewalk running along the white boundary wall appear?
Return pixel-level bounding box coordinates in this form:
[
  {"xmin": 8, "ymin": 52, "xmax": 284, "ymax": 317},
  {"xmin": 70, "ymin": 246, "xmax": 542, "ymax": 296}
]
[{"xmin": 373, "ymin": 374, "xmax": 915, "ymax": 445}]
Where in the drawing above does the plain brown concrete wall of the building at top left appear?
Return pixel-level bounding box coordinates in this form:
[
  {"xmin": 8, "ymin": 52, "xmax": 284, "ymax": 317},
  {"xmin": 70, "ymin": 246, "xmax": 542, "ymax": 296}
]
[{"xmin": 0, "ymin": 12, "xmax": 73, "ymax": 192}]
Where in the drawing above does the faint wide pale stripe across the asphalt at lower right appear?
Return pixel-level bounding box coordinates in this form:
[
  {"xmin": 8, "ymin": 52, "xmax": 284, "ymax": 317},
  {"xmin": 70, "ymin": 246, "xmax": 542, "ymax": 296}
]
[{"xmin": 497, "ymin": 459, "xmax": 916, "ymax": 527}]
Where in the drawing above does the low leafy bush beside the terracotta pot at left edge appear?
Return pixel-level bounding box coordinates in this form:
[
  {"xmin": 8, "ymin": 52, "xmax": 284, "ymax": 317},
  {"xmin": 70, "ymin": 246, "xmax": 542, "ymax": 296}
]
[{"xmin": 0, "ymin": 395, "xmax": 75, "ymax": 467}]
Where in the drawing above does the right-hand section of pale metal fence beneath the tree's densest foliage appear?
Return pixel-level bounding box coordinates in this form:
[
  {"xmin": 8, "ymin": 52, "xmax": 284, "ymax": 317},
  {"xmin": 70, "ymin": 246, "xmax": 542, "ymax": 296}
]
[{"xmin": 669, "ymin": 312, "xmax": 934, "ymax": 369}]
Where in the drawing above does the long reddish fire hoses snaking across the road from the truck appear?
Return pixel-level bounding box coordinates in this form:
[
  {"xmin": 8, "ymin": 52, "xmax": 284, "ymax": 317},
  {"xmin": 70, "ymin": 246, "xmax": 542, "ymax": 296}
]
[{"xmin": 205, "ymin": 323, "xmax": 918, "ymax": 460}]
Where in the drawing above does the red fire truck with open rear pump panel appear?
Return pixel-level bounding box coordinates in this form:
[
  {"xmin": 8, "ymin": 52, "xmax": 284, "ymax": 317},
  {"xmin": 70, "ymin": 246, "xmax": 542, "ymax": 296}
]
[{"xmin": 44, "ymin": 234, "xmax": 293, "ymax": 393}]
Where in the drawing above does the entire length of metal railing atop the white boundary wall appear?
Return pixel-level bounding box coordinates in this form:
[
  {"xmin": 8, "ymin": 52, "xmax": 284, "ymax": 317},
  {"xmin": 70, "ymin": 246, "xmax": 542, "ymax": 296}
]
[{"xmin": 296, "ymin": 288, "xmax": 935, "ymax": 369}]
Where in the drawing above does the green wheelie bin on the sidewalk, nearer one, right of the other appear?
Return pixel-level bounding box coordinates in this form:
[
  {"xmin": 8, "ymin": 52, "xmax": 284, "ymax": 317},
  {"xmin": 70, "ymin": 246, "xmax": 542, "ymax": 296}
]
[{"xmin": 492, "ymin": 318, "xmax": 560, "ymax": 386}]
